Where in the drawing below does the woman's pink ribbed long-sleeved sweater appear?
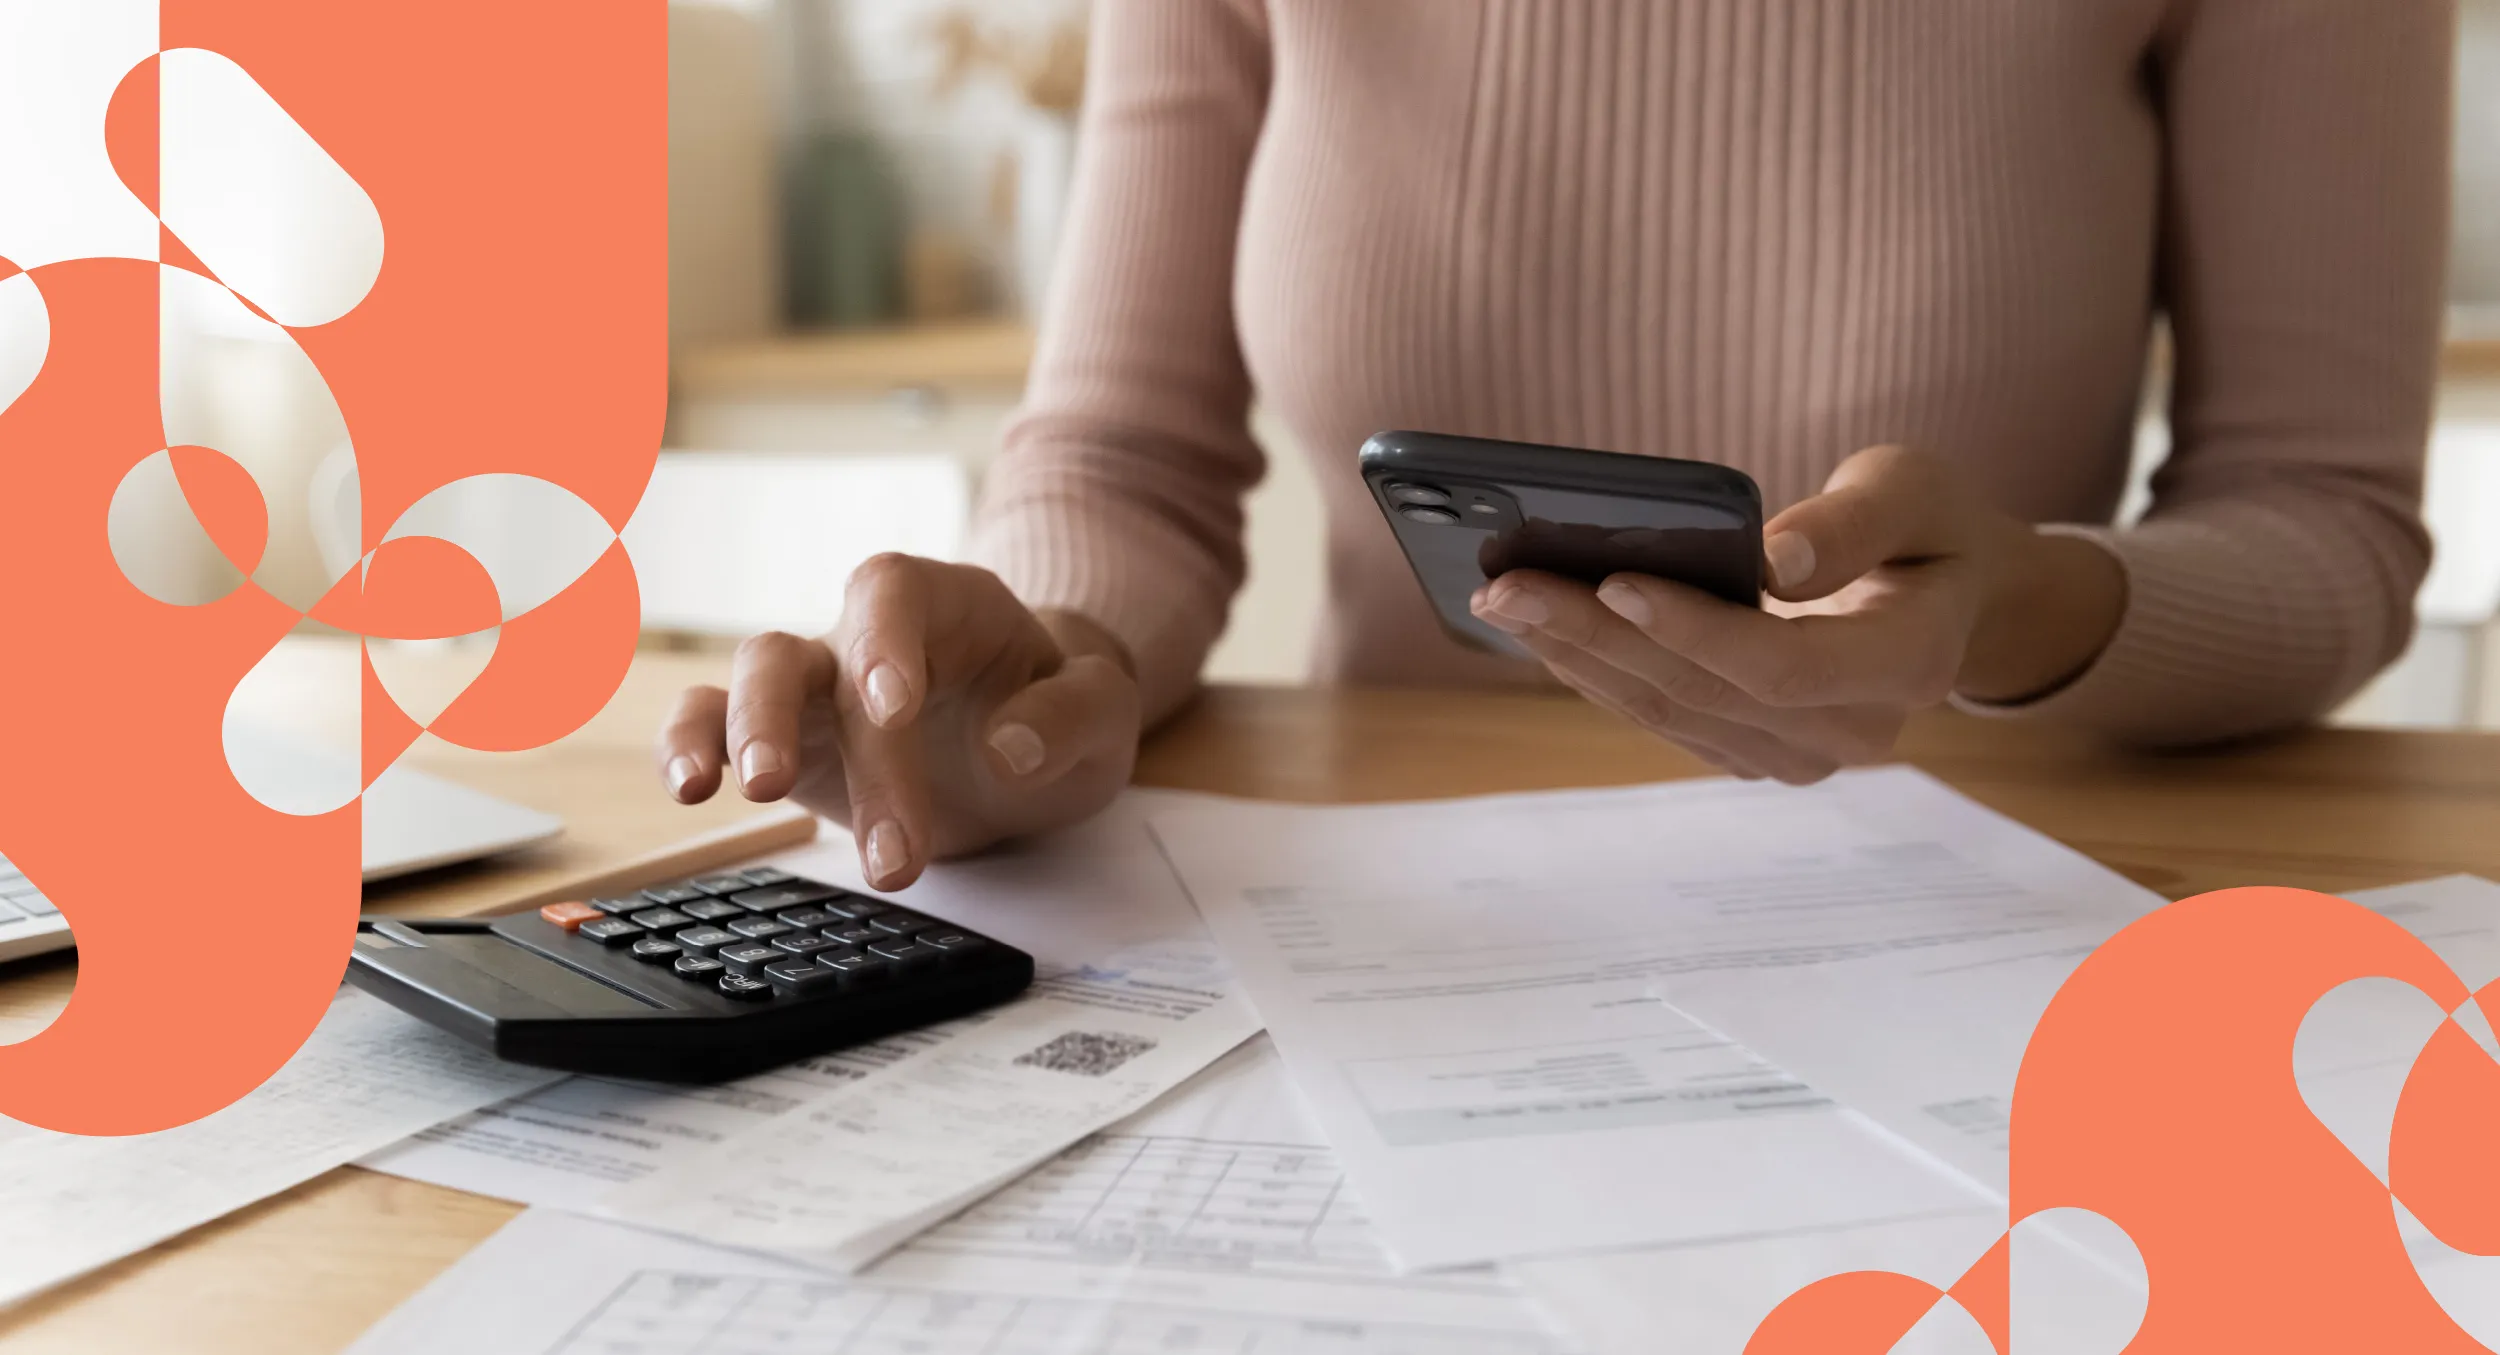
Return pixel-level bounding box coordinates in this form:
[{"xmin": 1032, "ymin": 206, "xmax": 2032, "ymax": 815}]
[{"xmin": 975, "ymin": 0, "xmax": 2455, "ymax": 740}]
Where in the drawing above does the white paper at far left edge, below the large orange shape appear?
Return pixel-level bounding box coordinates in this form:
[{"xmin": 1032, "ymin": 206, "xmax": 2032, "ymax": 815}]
[{"xmin": 0, "ymin": 990, "xmax": 555, "ymax": 1303}]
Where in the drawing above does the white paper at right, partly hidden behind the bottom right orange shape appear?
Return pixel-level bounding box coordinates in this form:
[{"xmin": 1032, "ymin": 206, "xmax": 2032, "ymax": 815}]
[{"xmin": 1658, "ymin": 878, "xmax": 2500, "ymax": 1198}]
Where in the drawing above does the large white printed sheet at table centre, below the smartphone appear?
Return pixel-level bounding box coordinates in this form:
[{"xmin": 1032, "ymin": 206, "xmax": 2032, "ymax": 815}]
[{"xmin": 1155, "ymin": 770, "xmax": 2160, "ymax": 1268}]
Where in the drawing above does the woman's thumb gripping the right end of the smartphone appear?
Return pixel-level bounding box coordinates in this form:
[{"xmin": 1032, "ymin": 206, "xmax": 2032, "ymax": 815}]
[{"xmin": 1763, "ymin": 448, "xmax": 1968, "ymax": 603}]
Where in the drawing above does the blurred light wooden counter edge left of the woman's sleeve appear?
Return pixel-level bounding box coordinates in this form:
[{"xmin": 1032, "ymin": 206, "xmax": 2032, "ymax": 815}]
[{"xmin": 675, "ymin": 320, "xmax": 1033, "ymax": 400}]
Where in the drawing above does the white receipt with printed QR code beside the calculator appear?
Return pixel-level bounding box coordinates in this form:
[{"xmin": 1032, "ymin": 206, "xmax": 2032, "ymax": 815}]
[{"xmin": 600, "ymin": 940, "xmax": 1258, "ymax": 1273}]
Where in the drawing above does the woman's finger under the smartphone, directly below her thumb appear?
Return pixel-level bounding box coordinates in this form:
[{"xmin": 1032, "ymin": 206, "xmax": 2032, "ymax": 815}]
[{"xmin": 1598, "ymin": 575, "xmax": 1965, "ymax": 710}]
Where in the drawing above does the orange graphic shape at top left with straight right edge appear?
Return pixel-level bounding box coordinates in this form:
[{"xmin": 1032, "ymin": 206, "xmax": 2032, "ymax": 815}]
[{"xmin": 163, "ymin": 0, "xmax": 668, "ymax": 548}]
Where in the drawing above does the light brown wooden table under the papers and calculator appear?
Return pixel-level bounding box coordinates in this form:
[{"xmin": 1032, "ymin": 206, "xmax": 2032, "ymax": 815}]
[{"xmin": 0, "ymin": 643, "xmax": 2500, "ymax": 1355}]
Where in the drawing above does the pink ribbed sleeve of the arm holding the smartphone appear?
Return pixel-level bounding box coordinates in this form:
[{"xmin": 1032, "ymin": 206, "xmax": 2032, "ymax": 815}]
[{"xmin": 2018, "ymin": 0, "xmax": 2455, "ymax": 743}]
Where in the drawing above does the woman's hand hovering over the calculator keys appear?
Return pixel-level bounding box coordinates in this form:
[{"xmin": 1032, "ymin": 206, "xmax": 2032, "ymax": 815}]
[{"xmin": 658, "ymin": 555, "xmax": 1140, "ymax": 890}]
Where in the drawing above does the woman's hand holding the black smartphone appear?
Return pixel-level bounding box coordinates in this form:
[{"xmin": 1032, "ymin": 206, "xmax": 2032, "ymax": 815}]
[{"xmin": 1475, "ymin": 448, "xmax": 2125, "ymax": 785}]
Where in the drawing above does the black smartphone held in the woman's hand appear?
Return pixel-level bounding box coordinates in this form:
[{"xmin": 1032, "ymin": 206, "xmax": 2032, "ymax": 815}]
[{"xmin": 1363, "ymin": 433, "xmax": 1763, "ymax": 653}]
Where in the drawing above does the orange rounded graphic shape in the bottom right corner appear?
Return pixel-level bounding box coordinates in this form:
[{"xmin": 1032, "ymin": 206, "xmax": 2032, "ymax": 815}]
[{"xmin": 1748, "ymin": 888, "xmax": 2500, "ymax": 1355}]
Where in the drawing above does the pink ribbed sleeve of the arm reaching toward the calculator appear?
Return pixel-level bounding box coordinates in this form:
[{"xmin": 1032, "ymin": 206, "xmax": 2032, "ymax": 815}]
[{"xmin": 973, "ymin": 0, "xmax": 1270, "ymax": 723}]
